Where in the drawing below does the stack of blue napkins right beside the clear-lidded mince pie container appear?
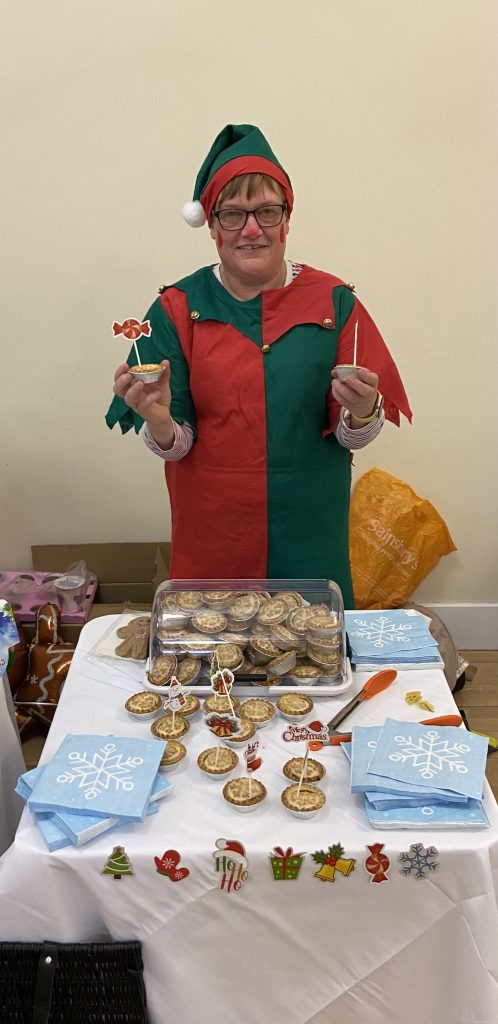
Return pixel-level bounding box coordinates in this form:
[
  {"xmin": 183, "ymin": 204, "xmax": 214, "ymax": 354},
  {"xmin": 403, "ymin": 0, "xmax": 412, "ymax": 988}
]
[{"xmin": 344, "ymin": 608, "xmax": 444, "ymax": 670}]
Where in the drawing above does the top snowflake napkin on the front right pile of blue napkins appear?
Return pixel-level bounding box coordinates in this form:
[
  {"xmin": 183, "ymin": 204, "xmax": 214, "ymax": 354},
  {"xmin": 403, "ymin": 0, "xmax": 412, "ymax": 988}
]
[{"xmin": 367, "ymin": 718, "xmax": 488, "ymax": 800}]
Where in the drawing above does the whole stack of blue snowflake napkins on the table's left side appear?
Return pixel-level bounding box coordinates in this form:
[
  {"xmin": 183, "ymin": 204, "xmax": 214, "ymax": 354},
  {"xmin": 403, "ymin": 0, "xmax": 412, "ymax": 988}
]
[{"xmin": 16, "ymin": 734, "xmax": 172, "ymax": 850}]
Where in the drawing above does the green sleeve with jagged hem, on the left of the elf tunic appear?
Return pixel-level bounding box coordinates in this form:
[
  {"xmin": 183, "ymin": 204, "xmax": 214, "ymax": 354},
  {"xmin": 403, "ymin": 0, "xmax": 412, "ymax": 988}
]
[{"xmin": 106, "ymin": 298, "xmax": 196, "ymax": 434}]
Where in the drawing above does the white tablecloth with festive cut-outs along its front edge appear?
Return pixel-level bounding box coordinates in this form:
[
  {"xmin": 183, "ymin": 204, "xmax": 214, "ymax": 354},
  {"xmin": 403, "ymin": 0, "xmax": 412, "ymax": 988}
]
[{"xmin": 0, "ymin": 617, "xmax": 498, "ymax": 1024}]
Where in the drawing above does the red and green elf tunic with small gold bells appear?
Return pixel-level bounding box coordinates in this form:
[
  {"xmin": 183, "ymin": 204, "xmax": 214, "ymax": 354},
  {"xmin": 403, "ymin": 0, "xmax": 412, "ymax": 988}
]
[{"xmin": 102, "ymin": 266, "xmax": 411, "ymax": 607}]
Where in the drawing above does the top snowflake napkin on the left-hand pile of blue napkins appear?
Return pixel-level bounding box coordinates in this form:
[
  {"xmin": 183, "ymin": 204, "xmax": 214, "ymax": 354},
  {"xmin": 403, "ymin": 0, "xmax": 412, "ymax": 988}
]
[{"xmin": 28, "ymin": 734, "xmax": 164, "ymax": 821}]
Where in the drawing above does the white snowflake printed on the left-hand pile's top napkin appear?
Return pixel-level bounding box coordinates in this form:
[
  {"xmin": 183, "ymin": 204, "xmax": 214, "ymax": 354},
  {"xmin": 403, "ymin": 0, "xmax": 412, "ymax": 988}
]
[{"xmin": 56, "ymin": 743, "xmax": 143, "ymax": 800}]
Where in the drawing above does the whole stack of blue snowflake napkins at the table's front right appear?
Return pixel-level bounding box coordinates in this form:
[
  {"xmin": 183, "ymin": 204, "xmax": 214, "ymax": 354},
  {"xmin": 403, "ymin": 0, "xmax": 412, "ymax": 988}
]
[{"xmin": 341, "ymin": 718, "xmax": 489, "ymax": 828}]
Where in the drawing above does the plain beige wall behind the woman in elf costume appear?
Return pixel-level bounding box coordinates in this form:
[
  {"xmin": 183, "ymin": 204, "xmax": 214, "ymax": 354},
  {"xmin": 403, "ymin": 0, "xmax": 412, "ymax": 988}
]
[{"xmin": 0, "ymin": 0, "xmax": 498, "ymax": 602}]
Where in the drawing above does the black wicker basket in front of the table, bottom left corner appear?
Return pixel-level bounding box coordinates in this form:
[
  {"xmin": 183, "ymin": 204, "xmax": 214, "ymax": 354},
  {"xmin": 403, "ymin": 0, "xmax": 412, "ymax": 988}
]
[{"xmin": 0, "ymin": 942, "xmax": 149, "ymax": 1024}]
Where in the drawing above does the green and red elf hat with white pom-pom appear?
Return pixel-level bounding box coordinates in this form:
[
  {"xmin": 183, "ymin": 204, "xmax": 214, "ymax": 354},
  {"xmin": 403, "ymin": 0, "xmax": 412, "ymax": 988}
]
[{"xmin": 181, "ymin": 125, "xmax": 294, "ymax": 227}]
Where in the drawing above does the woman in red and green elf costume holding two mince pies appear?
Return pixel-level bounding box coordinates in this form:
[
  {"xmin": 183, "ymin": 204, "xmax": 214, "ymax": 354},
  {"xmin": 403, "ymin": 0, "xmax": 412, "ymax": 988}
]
[{"xmin": 107, "ymin": 125, "xmax": 411, "ymax": 607}]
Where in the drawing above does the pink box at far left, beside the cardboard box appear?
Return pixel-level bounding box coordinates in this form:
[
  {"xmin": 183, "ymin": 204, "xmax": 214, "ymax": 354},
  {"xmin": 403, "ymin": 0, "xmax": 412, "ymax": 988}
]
[{"xmin": 0, "ymin": 570, "xmax": 98, "ymax": 624}]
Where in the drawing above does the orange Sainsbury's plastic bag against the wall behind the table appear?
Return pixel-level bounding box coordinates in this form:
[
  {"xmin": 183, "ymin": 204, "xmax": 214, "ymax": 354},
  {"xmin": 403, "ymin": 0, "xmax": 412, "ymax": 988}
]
[{"xmin": 349, "ymin": 468, "xmax": 457, "ymax": 608}]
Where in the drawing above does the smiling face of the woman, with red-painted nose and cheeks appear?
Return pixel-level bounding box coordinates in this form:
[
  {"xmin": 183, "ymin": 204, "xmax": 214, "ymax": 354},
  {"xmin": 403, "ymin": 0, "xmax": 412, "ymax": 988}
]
[{"xmin": 210, "ymin": 182, "xmax": 289, "ymax": 294}]
